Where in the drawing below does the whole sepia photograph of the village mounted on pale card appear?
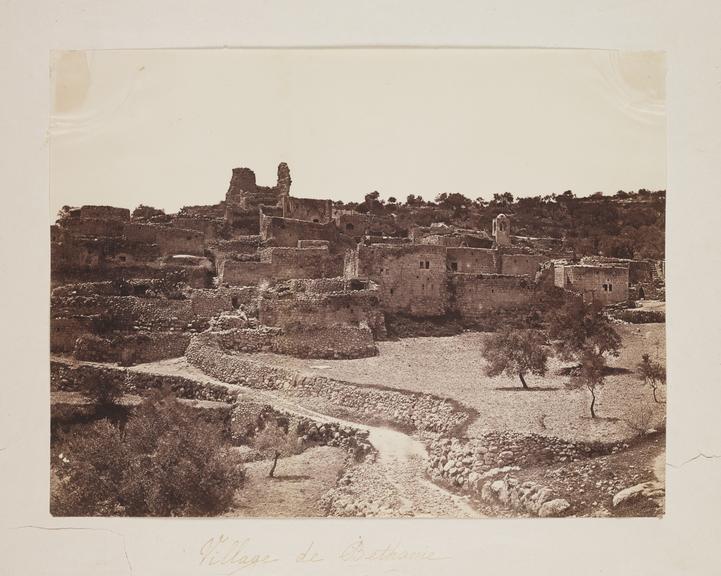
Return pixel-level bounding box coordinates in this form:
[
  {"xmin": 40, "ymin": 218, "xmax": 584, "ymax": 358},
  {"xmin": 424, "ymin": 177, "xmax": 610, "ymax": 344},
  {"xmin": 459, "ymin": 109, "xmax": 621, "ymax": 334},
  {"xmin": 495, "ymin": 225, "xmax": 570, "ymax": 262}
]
[{"xmin": 48, "ymin": 48, "xmax": 667, "ymax": 525}]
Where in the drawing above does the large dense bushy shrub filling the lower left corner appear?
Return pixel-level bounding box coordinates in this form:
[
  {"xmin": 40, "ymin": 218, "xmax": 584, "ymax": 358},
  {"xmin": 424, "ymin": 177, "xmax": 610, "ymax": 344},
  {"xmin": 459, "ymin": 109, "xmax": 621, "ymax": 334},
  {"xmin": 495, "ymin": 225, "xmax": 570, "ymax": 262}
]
[{"xmin": 51, "ymin": 391, "xmax": 244, "ymax": 516}]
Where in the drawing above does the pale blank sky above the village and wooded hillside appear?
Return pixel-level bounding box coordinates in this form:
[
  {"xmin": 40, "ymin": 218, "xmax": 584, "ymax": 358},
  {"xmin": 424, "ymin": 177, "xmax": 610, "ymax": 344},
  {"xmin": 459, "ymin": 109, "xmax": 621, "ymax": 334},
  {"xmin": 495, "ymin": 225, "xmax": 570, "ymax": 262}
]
[{"xmin": 50, "ymin": 49, "xmax": 666, "ymax": 214}]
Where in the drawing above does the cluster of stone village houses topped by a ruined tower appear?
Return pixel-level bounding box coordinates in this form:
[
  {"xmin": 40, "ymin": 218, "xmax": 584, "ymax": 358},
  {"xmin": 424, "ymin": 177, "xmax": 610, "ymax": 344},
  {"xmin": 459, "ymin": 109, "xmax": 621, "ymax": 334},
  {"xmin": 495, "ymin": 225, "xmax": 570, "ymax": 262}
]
[{"xmin": 51, "ymin": 164, "xmax": 663, "ymax": 363}]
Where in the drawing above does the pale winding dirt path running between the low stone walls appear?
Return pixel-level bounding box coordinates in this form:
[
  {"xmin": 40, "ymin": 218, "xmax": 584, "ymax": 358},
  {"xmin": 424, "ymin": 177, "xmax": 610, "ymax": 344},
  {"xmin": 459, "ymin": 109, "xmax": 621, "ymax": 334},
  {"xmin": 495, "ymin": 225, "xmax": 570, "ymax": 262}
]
[{"xmin": 129, "ymin": 358, "xmax": 482, "ymax": 518}]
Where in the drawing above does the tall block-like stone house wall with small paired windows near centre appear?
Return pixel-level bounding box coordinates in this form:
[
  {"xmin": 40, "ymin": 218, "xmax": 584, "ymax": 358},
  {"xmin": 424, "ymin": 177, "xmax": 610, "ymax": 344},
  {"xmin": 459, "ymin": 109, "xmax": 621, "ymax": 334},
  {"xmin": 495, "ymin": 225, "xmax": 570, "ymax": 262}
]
[{"xmin": 345, "ymin": 244, "xmax": 447, "ymax": 316}]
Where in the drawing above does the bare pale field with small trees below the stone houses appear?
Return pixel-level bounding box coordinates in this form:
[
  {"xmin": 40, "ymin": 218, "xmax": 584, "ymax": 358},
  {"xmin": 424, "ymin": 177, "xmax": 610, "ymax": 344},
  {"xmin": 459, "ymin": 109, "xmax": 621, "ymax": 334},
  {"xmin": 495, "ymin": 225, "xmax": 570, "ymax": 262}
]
[{"xmin": 252, "ymin": 324, "xmax": 665, "ymax": 442}]
